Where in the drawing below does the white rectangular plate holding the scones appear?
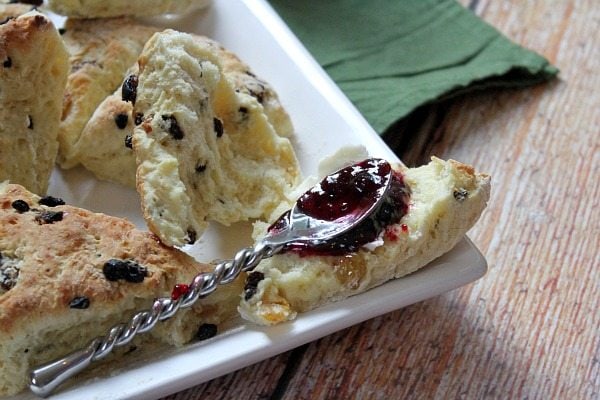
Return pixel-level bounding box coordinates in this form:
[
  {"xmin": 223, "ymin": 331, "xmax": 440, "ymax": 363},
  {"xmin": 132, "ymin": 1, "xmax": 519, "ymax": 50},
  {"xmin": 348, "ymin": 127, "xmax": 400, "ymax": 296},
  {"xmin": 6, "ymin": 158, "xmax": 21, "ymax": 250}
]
[{"xmin": 9, "ymin": 0, "xmax": 487, "ymax": 399}]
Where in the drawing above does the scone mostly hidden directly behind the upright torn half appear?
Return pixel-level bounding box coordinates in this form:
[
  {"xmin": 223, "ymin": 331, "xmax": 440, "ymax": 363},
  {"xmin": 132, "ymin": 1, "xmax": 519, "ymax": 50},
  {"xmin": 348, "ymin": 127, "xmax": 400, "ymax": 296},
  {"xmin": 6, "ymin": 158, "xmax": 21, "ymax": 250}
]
[{"xmin": 73, "ymin": 35, "xmax": 293, "ymax": 187}]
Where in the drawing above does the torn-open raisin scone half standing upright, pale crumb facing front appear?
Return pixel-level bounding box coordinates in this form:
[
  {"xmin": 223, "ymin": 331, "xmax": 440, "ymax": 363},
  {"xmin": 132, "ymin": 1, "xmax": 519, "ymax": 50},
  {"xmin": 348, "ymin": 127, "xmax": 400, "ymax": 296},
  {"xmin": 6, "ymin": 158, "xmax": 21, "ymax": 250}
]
[{"xmin": 132, "ymin": 30, "xmax": 299, "ymax": 245}]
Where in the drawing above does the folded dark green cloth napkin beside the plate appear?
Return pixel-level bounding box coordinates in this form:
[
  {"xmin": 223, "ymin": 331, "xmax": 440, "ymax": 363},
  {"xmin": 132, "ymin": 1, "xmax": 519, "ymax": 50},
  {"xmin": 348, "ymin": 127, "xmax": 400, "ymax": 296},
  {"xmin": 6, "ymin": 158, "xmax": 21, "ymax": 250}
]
[{"xmin": 270, "ymin": 0, "xmax": 558, "ymax": 134}]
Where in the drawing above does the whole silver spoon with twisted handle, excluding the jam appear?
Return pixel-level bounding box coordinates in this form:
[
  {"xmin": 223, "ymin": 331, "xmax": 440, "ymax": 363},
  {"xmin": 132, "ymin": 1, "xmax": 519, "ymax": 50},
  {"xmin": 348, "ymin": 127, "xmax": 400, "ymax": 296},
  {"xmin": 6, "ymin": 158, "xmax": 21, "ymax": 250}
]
[{"xmin": 29, "ymin": 160, "xmax": 392, "ymax": 397}]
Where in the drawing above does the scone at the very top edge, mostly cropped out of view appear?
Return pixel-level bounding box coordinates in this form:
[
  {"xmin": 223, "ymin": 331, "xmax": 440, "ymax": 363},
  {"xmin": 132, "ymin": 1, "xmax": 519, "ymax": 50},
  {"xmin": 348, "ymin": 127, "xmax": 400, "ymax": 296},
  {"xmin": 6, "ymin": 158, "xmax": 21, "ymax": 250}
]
[{"xmin": 48, "ymin": 0, "xmax": 210, "ymax": 18}]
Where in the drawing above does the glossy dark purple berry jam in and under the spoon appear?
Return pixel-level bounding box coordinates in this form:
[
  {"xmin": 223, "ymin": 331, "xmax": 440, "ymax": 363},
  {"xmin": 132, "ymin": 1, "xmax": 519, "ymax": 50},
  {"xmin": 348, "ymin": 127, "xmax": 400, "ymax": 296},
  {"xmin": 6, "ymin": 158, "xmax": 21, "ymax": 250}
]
[{"xmin": 269, "ymin": 158, "xmax": 410, "ymax": 256}]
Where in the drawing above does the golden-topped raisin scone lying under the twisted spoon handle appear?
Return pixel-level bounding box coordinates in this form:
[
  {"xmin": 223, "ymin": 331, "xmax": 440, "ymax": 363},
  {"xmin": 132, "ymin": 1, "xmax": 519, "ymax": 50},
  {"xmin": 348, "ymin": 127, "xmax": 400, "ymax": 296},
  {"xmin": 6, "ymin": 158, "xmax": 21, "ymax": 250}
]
[{"xmin": 0, "ymin": 183, "xmax": 242, "ymax": 395}]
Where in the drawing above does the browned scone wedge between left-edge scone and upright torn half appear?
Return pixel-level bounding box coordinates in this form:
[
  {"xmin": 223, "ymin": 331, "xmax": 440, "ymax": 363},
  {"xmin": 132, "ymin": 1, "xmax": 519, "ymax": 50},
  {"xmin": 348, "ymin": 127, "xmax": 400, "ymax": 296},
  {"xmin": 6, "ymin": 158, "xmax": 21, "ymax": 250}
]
[{"xmin": 58, "ymin": 18, "xmax": 157, "ymax": 168}]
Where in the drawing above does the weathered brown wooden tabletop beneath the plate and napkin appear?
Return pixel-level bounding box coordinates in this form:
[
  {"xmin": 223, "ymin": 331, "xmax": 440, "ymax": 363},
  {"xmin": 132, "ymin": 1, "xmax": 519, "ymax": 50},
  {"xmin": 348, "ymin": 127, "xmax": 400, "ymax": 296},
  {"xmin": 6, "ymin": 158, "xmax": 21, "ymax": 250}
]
[{"xmin": 162, "ymin": 0, "xmax": 600, "ymax": 400}]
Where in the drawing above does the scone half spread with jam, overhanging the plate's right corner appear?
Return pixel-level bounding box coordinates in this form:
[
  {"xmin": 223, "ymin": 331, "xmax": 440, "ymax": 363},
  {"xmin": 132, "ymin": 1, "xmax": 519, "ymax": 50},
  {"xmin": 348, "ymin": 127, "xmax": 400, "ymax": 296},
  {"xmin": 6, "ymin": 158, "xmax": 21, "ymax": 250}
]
[{"xmin": 238, "ymin": 158, "xmax": 490, "ymax": 325}]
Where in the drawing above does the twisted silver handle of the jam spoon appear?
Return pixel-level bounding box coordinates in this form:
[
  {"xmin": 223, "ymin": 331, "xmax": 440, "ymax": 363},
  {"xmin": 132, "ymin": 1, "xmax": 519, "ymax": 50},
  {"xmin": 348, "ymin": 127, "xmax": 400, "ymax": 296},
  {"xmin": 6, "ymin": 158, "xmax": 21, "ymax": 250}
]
[{"xmin": 29, "ymin": 241, "xmax": 283, "ymax": 397}]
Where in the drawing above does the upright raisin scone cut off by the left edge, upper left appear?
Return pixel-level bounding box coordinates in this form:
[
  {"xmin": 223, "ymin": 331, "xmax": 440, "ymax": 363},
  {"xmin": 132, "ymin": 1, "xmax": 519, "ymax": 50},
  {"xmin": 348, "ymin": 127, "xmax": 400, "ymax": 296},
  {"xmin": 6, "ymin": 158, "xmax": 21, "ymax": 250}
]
[{"xmin": 0, "ymin": 11, "xmax": 69, "ymax": 194}]
